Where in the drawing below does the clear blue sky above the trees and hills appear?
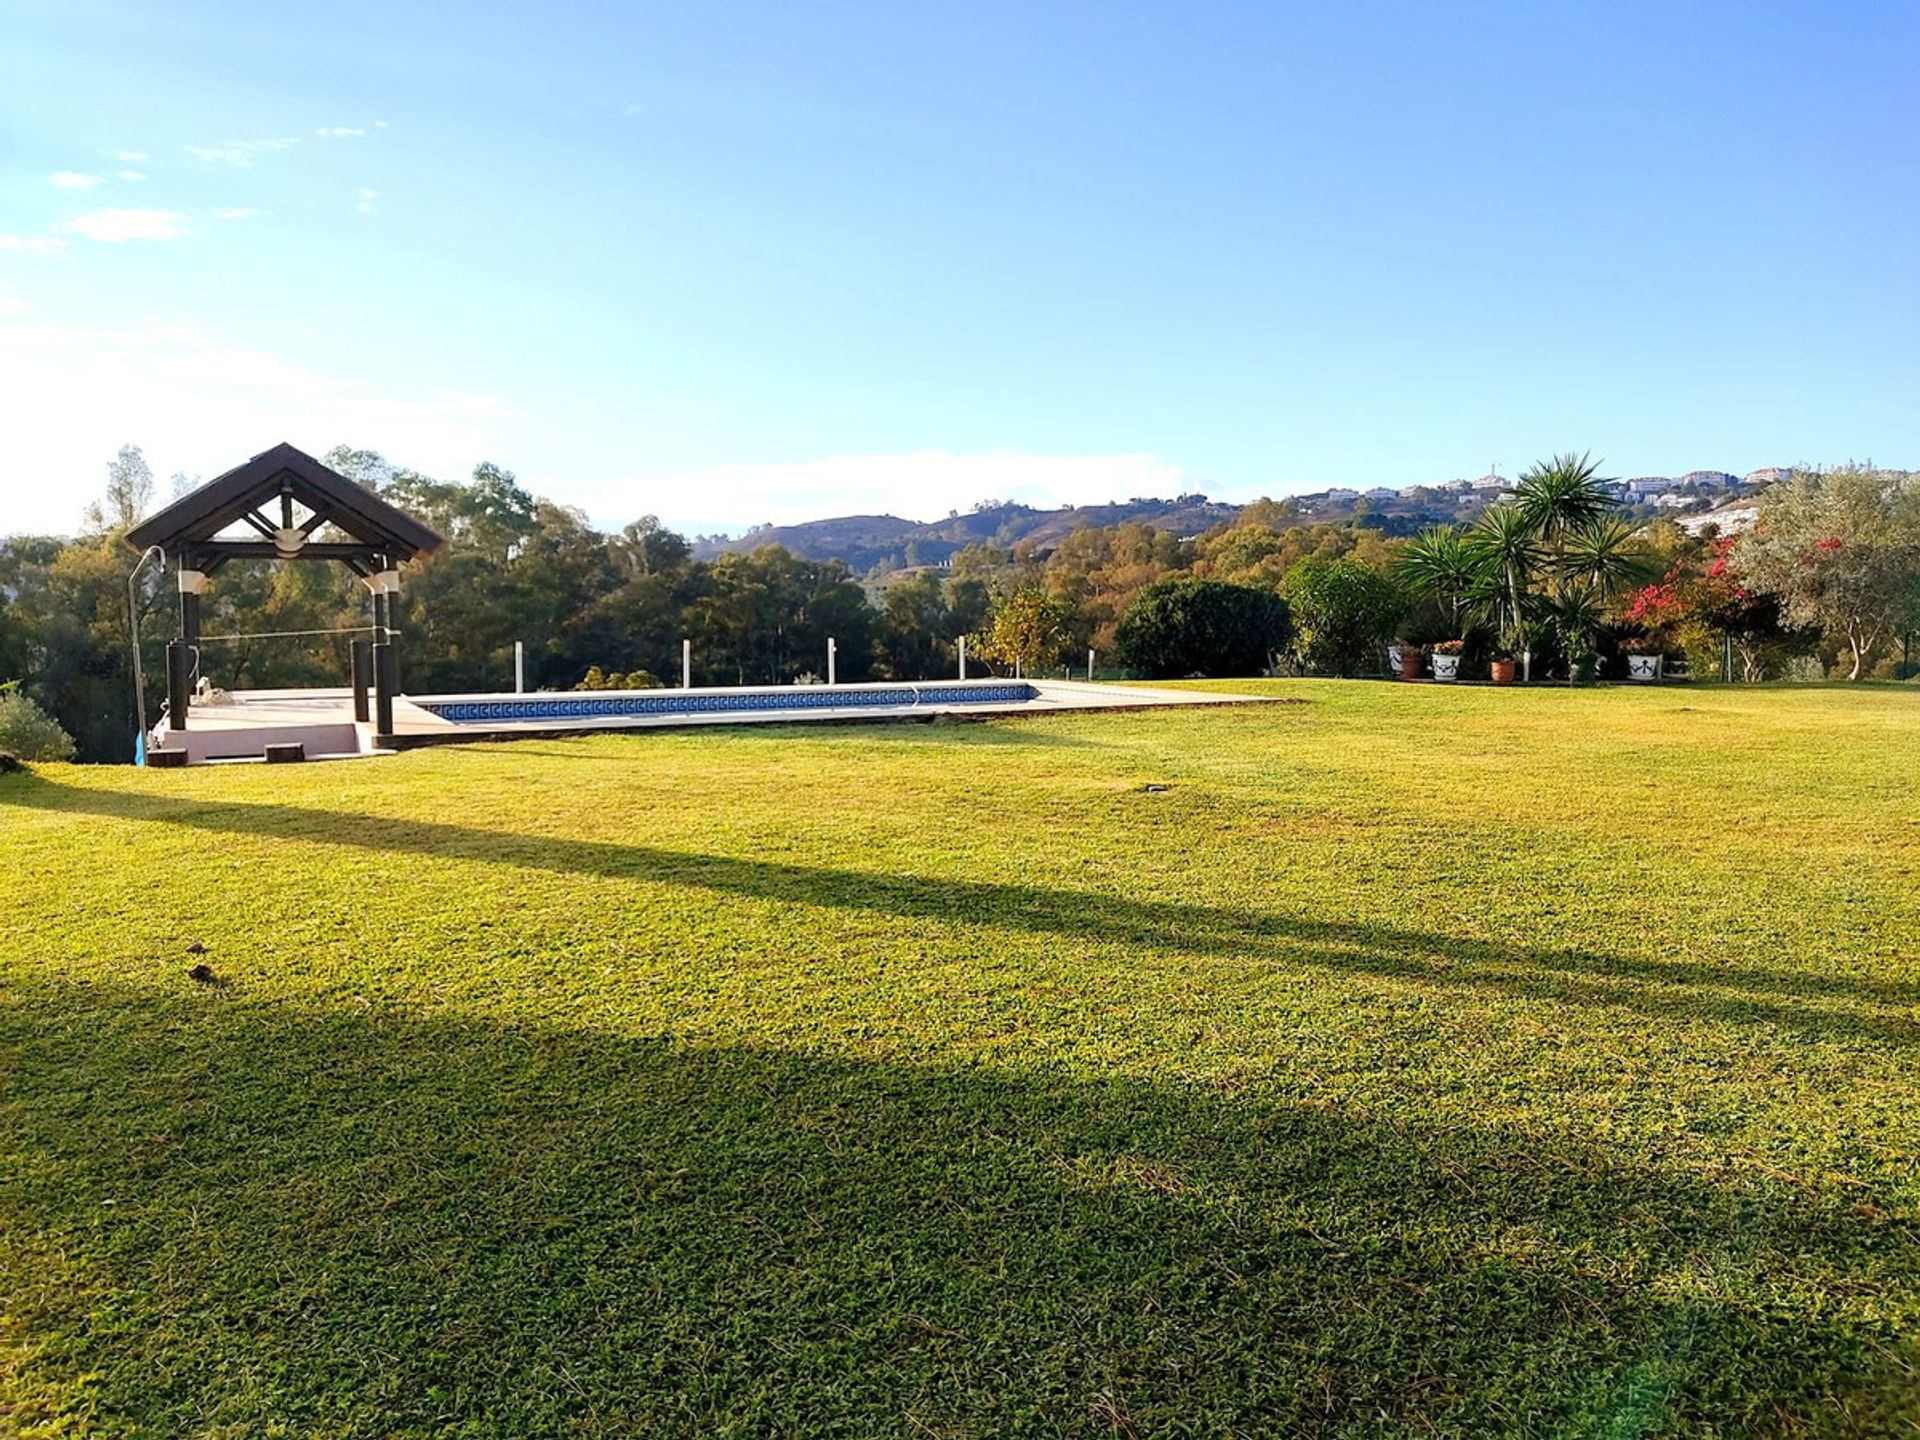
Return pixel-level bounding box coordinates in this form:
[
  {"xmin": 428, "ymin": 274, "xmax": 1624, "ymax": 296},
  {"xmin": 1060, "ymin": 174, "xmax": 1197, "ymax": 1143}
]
[{"xmin": 0, "ymin": 0, "xmax": 1920, "ymax": 532}]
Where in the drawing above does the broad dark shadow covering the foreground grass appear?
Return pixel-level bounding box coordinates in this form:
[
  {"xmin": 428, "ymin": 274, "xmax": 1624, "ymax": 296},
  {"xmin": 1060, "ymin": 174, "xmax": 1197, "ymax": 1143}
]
[{"xmin": 0, "ymin": 979, "xmax": 1912, "ymax": 1436}]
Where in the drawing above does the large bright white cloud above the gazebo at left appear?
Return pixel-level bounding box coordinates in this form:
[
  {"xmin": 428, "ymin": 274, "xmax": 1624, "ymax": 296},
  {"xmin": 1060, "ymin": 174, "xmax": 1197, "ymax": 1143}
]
[{"xmin": 0, "ymin": 319, "xmax": 513, "ymax": 534}]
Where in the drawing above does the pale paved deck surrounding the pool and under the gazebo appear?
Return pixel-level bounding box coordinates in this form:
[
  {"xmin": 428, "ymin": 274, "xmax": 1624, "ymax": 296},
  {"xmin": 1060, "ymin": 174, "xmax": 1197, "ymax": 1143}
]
[{"xmin": 150, "ymin": 680, "xmax": 1261, "ymax": 764}]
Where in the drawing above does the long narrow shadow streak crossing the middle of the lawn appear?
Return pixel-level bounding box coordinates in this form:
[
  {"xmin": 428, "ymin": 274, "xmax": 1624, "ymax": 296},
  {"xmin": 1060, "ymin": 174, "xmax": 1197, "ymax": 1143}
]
[{"xmin": 11, "ymin": 776, "xmax": 1920, "ymax": 1046}]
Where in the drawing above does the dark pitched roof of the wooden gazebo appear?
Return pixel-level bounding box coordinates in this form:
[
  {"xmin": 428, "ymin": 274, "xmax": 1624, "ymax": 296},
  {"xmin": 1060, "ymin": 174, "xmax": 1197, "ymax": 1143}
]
[{"xmin": 127, "ymin": 442, "xmax": 445, "ymax": 572}]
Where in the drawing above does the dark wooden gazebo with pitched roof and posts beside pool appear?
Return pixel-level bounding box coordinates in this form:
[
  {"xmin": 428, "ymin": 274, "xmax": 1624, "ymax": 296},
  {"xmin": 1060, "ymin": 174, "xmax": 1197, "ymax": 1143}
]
[{"xmin": 127, "ymin": 444, "xmax": 445, "ymax": 737}]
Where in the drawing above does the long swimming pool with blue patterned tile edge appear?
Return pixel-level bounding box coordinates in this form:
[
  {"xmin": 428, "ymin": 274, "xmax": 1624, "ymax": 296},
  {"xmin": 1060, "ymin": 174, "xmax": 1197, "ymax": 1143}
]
[{"xmin": 413, "ymin": 680, "xmax": 1041, "ymax": 726}]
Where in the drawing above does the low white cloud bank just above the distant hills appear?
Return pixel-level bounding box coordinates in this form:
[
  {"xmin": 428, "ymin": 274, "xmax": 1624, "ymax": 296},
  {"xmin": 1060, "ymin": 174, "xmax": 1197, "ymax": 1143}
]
[{"xmin": 583, "ymin": 449, "xmax": 1190, "ymax": 524}]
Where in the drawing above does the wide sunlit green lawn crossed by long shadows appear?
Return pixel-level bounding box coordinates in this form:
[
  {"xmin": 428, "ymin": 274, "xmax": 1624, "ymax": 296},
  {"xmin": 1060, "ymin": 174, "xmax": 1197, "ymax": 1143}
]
[{"xmin": 0, "ymin": 682, "xmax": 1920, "ymax": 1438}]
